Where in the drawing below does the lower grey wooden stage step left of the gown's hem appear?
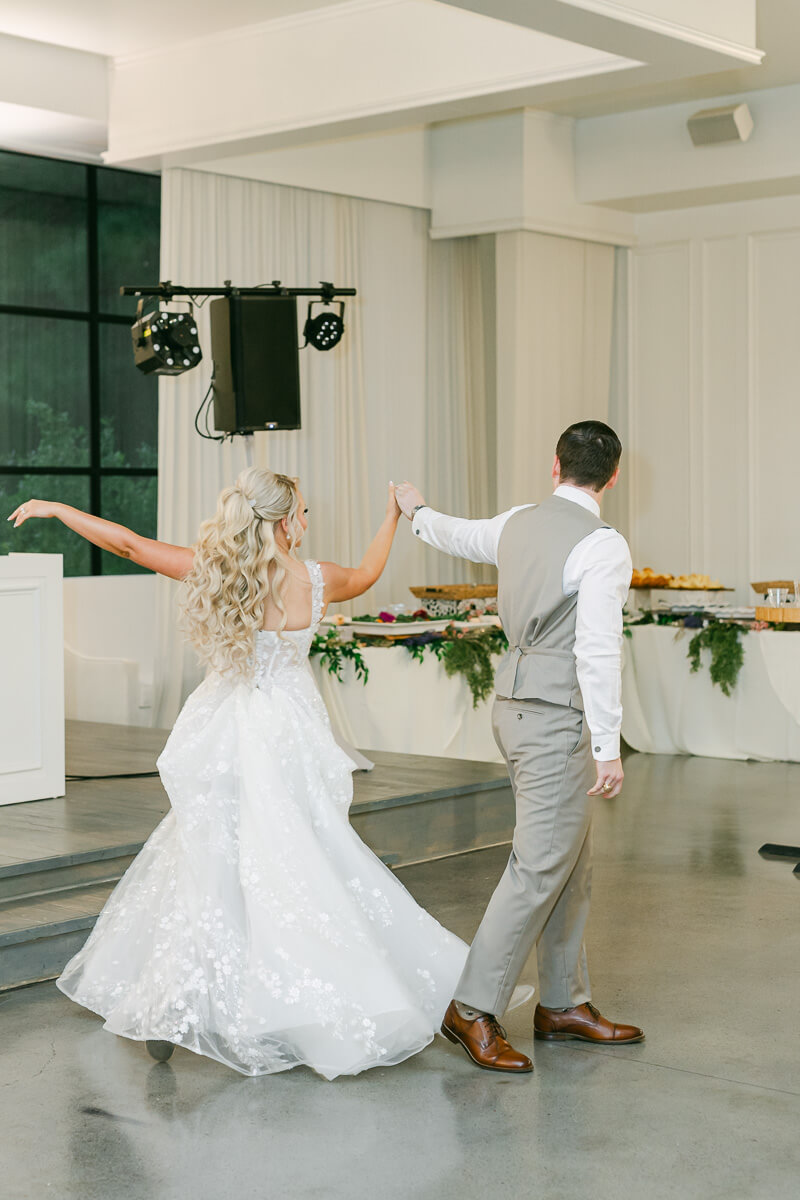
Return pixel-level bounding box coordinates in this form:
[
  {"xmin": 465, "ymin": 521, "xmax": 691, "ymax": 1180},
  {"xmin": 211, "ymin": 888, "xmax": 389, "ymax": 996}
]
[{"xmin": 0, "ymin": 881, "xmax": 116, "ymax": 991}]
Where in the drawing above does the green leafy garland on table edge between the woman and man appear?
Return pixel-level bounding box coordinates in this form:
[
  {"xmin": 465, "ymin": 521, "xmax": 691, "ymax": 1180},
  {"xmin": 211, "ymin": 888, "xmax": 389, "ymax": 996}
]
[{"xmin": 309, "ymin": 626, "xmax": 509, "ymax": 708}]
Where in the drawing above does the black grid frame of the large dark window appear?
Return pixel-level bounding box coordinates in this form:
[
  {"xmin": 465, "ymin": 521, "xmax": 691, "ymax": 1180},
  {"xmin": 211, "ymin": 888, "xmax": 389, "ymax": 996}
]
[{"xmin": 0, "ymin": 150, "xmax": 158, "ymax": 576}]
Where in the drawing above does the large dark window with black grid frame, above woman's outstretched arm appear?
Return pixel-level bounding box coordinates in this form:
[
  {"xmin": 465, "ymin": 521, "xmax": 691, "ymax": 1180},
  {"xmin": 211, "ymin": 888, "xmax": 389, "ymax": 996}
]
[{"xmin": 0, "ymin": 151, "xmax": 161, "ymax": 575}]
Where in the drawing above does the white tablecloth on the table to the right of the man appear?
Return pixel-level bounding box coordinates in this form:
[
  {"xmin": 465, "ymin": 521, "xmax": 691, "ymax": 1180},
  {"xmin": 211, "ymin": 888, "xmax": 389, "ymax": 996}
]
[{"xmin": 622, "ymin": 625, "xmax": 800, "ymax": 762}]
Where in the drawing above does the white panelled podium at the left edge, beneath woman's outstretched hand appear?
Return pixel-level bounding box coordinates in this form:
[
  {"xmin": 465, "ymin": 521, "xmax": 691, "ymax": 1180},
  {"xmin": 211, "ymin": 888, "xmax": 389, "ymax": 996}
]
[{"xmin": 0, "ymin": 554, "xmax": 65, "ymax": 804}]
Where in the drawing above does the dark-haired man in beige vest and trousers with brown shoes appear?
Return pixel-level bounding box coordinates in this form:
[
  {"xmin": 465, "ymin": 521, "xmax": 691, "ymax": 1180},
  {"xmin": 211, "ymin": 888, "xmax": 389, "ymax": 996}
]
[{"xmin": 397, "ymin": 421, "xmax": 644, "ymax": 1072}]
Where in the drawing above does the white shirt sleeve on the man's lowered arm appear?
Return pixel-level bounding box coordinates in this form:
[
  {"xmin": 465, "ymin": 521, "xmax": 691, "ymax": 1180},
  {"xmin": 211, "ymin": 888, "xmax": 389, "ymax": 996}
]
[{"xmin": 565, "ymin": 529, "xmax": 633, "ymax": 762}]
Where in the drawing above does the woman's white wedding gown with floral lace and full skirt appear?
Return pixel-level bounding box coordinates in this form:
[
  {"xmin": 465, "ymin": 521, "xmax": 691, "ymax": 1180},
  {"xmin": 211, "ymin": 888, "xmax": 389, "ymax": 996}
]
[{"xmin": 58, "ymin": 562, "xmax": 467, "ymax": 1079}]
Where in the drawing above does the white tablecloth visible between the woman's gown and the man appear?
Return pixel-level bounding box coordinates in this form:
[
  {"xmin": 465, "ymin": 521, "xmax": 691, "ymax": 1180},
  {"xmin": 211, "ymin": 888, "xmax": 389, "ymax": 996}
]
[{"xmin": 312, "ymin": 646, "xmax": 503, "ymax": 762}]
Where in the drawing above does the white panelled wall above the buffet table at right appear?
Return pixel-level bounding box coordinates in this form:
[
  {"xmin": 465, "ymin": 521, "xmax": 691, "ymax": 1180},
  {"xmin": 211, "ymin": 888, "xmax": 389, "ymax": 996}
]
[{"xmin": 616, "ymin": 198, "xmax": 800, "ymax": 602}]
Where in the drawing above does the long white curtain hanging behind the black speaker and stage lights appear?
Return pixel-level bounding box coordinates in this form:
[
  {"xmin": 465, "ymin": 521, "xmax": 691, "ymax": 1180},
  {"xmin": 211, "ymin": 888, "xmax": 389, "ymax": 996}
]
[{"xmin": 154, "ymin": 169, "xmax": 489, "ymax": 726}]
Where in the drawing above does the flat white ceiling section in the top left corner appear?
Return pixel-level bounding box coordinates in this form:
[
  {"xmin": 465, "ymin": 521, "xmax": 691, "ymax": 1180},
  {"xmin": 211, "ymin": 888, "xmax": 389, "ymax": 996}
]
[{"xmin": 0, "ymin": 0, "xmax": 344, "ymax": 56}]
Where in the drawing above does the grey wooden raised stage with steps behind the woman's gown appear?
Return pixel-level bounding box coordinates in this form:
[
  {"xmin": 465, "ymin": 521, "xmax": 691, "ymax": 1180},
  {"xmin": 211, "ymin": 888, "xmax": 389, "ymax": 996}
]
[{"xmin": 0, "ymin": 721, "xmax": 513, "ymax": 990}]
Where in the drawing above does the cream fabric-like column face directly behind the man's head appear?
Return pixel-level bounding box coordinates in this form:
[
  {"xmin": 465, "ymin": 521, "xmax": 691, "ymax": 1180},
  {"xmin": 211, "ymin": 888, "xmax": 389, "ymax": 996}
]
[{"xmin": 497, "ymin": 233, "xmax": 614, "ymax": 509}]
